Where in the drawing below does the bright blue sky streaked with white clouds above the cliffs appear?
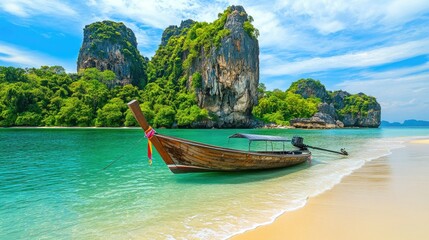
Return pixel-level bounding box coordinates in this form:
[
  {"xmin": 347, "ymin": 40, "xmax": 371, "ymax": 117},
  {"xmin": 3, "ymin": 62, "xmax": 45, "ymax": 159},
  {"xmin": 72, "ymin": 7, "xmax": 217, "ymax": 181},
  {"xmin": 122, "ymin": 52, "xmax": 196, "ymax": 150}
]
[{"xmin": 0, "ymin": 0, "xmax": 429, "ymax": 121}]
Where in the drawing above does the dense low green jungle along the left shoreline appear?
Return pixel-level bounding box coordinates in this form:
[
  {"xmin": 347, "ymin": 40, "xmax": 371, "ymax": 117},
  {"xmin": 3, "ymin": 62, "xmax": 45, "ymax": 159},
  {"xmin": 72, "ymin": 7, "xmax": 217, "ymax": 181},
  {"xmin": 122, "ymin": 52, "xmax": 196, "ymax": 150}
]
[{"xmin": 0, "ymin": 66, "xmax": 142, "ymax": 127}]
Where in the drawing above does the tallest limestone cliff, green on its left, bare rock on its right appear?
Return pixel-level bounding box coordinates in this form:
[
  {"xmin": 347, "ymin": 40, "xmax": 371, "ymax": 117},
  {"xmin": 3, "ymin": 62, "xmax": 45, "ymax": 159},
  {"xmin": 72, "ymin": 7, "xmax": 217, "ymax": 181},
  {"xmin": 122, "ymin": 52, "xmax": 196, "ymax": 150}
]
[{"xmin": 143, "ymin": 6, "xmax": 259, "ymax": 128}]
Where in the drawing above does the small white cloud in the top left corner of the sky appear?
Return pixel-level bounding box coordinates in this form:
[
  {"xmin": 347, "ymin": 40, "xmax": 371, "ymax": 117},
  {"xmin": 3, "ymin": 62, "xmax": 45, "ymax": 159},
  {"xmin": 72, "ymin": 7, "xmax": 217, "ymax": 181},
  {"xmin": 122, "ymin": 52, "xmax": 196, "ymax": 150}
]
[{"xmin": 0, "ymin": 0, "xmax": 77, "ymax": 18}]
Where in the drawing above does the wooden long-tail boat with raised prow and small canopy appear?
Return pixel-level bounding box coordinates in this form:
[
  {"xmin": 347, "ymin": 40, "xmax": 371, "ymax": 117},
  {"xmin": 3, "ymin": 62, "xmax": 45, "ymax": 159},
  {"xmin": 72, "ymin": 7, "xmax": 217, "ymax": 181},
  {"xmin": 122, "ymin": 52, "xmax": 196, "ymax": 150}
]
[{"xmin": 128, "ymin": 100, "xmax": 311, "ymax": 173}]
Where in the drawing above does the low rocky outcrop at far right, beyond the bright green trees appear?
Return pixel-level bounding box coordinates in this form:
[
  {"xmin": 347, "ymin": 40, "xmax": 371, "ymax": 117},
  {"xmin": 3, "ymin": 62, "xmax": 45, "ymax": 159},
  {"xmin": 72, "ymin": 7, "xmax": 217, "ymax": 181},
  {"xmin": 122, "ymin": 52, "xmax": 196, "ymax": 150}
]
[{"xmin": 290, "ymin": 79, "xmax": 381, "ymax": 128}]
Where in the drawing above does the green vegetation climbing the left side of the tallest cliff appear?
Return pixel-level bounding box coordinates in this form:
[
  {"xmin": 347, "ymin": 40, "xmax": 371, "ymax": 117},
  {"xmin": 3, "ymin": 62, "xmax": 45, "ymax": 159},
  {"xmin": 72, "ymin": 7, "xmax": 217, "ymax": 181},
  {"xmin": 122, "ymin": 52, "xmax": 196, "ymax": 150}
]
[{"xmin": 143, "ymin": 8, "xmax": 255, "ymax": 127}]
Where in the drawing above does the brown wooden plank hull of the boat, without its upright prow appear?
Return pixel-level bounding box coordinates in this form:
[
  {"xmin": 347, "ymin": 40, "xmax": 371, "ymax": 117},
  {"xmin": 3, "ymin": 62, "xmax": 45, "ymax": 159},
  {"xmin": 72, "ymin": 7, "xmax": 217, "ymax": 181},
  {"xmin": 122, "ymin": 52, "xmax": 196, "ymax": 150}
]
[{"xmin": 154, "ymin": 134, "xmax": 311, "ymax": 173}]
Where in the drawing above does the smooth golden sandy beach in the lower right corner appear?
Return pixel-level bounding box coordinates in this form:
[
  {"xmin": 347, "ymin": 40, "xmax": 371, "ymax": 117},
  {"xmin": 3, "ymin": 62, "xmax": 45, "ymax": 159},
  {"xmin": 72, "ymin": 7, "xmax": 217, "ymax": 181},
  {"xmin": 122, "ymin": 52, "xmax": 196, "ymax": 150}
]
[{"xmin": 231, "ymin": 139, "xmax": 429, "ymax": 240}]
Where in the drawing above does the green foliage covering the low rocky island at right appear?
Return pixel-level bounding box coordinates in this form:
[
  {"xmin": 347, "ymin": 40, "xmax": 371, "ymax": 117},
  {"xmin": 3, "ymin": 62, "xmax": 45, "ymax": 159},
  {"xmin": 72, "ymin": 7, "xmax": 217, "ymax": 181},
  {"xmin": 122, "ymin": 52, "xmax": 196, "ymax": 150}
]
[{"xmin": 252, "ymin": 78, "xmax": 378, "ymax": 126}]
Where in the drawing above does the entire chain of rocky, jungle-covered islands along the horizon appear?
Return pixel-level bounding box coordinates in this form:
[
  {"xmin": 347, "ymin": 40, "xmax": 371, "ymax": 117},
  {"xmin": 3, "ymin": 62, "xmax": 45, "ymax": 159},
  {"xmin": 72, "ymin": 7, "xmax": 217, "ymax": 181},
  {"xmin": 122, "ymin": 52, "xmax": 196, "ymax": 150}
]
[{"xmin": 0, "ymin": 6, "xmax": 381, "ymax": 128}]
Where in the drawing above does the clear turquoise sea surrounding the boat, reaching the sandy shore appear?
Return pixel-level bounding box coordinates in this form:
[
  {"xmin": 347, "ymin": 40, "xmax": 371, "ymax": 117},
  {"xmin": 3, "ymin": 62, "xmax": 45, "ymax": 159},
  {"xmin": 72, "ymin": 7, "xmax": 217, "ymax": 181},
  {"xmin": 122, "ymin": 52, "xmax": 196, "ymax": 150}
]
[{"xmin": 0, "ymin": 128, "xmax": 429, "ymax": 239}]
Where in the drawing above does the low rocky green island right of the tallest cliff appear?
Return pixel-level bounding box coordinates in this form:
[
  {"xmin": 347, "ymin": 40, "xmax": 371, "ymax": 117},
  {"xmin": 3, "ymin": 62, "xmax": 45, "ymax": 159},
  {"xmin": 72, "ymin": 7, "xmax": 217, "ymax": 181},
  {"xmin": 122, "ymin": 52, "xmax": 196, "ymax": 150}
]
[{"xmin": 253, "ymin": 78, "xmax": 381, "ymax": 128}]
